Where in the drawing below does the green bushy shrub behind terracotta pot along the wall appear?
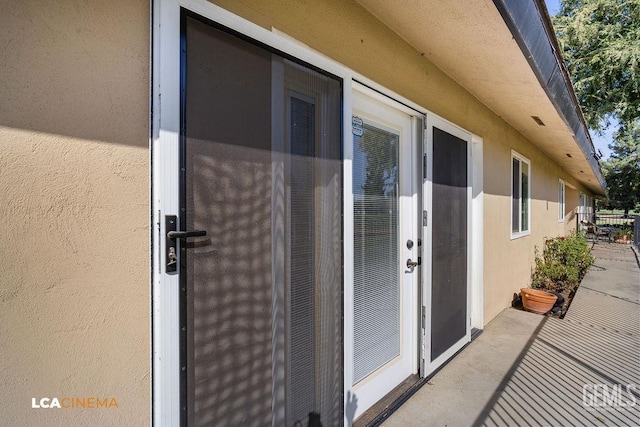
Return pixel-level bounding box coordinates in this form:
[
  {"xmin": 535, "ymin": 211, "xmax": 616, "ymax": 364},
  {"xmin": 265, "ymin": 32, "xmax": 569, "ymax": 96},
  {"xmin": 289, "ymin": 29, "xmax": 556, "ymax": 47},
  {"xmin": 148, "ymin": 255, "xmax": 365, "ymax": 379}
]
[{"xmin": 531, "ymin": 232, "xmax": 594, "ymax": 292}]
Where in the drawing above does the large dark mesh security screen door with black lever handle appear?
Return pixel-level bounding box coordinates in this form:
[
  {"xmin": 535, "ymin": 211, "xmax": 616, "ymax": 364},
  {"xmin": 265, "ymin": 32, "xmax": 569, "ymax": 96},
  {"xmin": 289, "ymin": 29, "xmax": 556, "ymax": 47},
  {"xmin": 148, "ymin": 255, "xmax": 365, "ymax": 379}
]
[{"xmin": 179, "ymin": 12, "xmax": 343, "ymax": 426}]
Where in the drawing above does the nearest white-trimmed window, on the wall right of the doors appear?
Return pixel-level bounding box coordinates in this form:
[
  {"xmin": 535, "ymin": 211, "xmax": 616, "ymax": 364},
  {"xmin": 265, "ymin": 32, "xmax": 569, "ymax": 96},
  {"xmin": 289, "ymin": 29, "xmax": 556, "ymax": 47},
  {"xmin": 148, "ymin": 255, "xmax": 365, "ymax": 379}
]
[{"xmin": 511, "ymin": 151, "xmax": 531, "ymax": 238}]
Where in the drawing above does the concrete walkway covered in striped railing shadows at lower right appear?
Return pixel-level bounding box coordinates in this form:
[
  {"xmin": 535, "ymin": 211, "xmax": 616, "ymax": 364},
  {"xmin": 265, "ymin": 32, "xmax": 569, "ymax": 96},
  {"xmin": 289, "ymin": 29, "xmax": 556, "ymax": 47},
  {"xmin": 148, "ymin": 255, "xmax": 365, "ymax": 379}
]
[{"xmin": 473, "ymin": 247, "xmax": 640, "ymax": 426}]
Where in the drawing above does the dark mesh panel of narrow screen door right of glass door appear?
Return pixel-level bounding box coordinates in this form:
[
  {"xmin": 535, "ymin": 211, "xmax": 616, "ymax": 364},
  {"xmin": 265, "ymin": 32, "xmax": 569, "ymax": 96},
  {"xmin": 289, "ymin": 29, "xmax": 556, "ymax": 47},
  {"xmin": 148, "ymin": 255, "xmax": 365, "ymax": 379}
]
[{"xmin": 431, "ymin": 128, "xmax": 467, "ymax": 360}]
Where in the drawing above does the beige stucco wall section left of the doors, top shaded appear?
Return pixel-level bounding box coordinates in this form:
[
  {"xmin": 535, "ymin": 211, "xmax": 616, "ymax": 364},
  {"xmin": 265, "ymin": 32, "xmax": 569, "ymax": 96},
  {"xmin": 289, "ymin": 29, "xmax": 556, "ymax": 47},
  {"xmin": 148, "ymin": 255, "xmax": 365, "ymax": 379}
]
[{"xmin": 0, "ymin": 0, "xmax": 150, "ymax": 426}]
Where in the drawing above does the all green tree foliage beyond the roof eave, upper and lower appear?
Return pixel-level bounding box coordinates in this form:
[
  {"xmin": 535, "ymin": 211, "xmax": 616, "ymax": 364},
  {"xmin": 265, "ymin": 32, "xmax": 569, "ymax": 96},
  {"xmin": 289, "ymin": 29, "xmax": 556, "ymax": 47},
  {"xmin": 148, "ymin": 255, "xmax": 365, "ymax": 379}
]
[{"xmin": 553, "ymin": 0, "xmax": 640, "ymax": 212}]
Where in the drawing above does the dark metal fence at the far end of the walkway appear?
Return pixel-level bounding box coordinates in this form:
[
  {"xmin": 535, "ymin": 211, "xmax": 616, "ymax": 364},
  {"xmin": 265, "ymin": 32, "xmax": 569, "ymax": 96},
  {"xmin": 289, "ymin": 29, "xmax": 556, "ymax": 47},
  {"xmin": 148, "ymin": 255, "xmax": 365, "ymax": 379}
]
[{"xmin": 576, "ymin": 212, "xmax": 640, "ymax": 249}]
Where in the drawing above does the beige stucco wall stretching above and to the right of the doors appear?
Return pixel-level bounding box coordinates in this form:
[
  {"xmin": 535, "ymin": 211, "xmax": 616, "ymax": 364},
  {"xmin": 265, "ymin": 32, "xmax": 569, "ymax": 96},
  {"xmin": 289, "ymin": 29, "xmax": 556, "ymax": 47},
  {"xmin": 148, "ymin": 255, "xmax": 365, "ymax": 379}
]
[{"xmin": 214, "ymin": 0, "xmax": 600, "ymax": 323}]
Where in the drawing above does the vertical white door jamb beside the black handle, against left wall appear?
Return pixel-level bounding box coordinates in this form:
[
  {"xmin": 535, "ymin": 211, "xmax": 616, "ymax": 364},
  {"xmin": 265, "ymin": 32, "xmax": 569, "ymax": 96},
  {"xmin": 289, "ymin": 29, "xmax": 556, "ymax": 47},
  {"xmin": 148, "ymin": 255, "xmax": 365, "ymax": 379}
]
[{"xmin": 151, "ymin": 0, "xmax": 180, "ymax": 426}]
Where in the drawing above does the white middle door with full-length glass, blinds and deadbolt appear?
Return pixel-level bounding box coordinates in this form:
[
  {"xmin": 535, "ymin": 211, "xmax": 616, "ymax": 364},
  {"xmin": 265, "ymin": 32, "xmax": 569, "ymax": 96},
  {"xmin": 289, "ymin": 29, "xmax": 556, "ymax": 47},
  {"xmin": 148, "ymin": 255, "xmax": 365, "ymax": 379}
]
[{"xmin": 352, "ymin": 88, "xmax": 418, "ymax": 418}]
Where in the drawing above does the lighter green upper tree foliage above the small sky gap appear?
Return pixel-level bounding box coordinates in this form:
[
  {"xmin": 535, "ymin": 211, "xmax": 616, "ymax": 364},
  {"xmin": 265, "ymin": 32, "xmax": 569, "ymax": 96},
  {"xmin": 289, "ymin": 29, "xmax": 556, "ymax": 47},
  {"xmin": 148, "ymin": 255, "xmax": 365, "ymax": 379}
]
[{"xmin": 553, "ymin": 0, "xmax": 640, "ymax": 131}]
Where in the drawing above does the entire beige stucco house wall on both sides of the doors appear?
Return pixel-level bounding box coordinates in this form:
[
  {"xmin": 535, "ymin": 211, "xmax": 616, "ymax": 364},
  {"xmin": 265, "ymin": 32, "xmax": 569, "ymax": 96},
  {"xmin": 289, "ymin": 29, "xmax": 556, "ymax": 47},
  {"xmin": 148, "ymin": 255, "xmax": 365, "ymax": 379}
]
[{"xmin": 0, "ymin": 0, "xmax": 600, "ymax": 425}]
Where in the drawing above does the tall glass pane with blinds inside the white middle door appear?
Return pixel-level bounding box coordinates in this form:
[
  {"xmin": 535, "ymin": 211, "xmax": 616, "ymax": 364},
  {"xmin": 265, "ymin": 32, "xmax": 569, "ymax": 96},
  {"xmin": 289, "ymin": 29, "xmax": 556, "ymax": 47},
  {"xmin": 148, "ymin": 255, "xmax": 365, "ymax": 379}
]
[{"xmin": 353, "ymin": 123, "xmax": 400, "ymax": 384}]
